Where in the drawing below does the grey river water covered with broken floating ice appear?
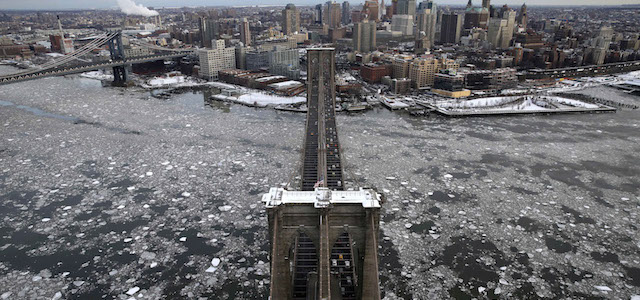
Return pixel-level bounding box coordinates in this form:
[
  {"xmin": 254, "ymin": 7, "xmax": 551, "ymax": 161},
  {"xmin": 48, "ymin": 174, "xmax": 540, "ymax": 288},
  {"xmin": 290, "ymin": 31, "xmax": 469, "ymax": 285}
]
[{"xmin": 0, "ymin": 68, "xmax": 640, "ymax": 299}]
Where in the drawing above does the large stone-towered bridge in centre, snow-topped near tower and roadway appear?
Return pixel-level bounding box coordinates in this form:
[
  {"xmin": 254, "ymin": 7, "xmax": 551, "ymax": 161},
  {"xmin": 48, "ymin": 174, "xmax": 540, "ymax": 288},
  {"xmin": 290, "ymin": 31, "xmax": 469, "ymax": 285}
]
[{"xmin": 262, "ymin": 48, "xmax": 382, "ymax": 300}]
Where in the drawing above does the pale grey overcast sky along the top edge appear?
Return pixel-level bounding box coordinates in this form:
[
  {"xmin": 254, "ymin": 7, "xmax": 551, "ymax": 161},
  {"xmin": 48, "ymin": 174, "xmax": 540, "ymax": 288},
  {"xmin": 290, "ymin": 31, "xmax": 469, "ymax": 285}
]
[{"xmin": 0, "ymin": 0, "xmax": 640, "ymax": 10}]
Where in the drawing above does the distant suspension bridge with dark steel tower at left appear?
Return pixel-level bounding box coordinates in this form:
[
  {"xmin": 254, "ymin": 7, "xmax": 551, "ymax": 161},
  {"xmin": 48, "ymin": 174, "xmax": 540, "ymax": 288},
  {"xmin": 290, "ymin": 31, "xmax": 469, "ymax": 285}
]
[{"xmin": 0, "ymin": 31, "xmax": 194, "ymax": 85}]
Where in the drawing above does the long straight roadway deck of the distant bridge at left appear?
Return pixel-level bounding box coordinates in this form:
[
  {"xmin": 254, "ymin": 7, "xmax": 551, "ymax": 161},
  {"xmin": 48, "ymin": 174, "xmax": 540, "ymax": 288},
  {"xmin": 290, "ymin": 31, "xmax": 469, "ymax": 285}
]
[{"xmin": 0, "ymin": 51, "xmax": 193, "ymax": 85}]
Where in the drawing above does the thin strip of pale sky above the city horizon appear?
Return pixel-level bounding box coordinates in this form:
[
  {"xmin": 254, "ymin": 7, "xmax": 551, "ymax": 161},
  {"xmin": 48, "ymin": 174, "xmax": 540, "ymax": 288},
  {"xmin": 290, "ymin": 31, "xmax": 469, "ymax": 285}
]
[{"xmin": 0, "ymin": 0, "xmax": 640, "ymax": 10}]
